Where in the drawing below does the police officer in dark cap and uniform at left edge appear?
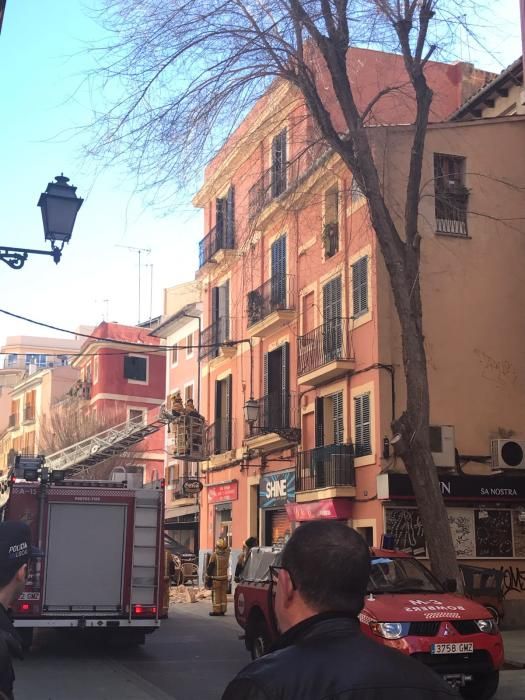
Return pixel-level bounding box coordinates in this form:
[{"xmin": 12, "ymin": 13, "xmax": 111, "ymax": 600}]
[{"xmin": 0, "ymin": 521, "xmax": 40, "ymax": 700}]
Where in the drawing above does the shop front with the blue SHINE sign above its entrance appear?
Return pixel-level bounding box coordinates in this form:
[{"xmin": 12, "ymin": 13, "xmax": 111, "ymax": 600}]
[{"xmin": 259, "ymin": 469, "xmax": 295, "ymax": 546}]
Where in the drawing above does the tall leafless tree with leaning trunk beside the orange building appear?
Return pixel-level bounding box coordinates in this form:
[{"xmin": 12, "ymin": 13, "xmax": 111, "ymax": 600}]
[{"xmin": 85, "ymin": 0, "xmax": 492, "ymax": 580}]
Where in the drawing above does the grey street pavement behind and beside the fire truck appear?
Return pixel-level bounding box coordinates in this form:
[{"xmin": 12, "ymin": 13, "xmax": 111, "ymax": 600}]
[{"xmin": 12, "ymin": 602, "xmax": 525, "ymax": 700}]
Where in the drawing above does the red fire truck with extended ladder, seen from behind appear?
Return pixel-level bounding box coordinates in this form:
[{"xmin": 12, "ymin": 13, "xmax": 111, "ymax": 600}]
[{"xmin": 0, "ymin": 409, "xmax": 207, "ymax": 647}]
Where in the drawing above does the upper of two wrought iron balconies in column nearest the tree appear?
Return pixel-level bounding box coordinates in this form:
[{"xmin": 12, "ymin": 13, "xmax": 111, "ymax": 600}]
[{"xmin": 297, "ymin": 318, "xmax": 354, "ymax": 386}]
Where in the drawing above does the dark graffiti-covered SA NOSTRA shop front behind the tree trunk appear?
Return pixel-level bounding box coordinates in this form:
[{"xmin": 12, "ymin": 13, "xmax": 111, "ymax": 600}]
[{"xmin": 377, "ymin": 474, "xmax": 525, "ymax": 625}]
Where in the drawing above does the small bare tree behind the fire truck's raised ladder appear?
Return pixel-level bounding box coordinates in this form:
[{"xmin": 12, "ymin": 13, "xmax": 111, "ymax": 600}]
[{"xmin": 40, "ymin": 396, "xmax": 145, "ymax": 479}]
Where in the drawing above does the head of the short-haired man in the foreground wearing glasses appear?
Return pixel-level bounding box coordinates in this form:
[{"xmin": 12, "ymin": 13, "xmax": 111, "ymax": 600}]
[{"xmin": 272, "ymin": 520, "xmax": 370, "ymax": 632}]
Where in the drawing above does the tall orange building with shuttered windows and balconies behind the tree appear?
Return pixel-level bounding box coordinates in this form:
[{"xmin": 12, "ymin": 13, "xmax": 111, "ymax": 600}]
[{"xmin": 194, "ymin": 51, "xmax": 525, "ymax": 624}]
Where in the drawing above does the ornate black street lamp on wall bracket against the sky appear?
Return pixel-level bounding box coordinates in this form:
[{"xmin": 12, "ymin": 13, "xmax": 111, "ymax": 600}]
[{"xmin": 0, "ymin": 174, "xmax": 84, "ymax": 270}]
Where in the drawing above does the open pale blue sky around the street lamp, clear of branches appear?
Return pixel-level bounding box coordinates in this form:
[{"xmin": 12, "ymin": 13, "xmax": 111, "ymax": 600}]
[{"xmin": 0, "ymin": 0, "xmax": 521, "ymax": 342}]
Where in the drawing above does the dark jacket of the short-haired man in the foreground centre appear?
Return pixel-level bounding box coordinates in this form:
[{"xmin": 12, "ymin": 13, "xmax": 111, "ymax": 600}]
[{"xmin": 222, "ymin": 613, "xmax": 458, "ymax": 700}]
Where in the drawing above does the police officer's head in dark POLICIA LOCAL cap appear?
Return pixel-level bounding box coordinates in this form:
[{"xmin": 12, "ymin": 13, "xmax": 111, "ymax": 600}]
[{"xmin": 0, "ymin": 521, "xmax": 39, "ymax": 608}]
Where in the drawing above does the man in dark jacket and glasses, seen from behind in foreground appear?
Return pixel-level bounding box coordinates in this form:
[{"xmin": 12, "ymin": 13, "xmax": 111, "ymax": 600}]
[{"xmin": 222, "ymin": 520, "xmax": 458, "ymax": 700}]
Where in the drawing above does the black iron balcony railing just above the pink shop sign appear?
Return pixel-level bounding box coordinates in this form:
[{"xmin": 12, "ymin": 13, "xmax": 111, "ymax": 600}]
[{"xmin": 296, "ymin": 444, "xmax": 355, "ymax": 491}]
